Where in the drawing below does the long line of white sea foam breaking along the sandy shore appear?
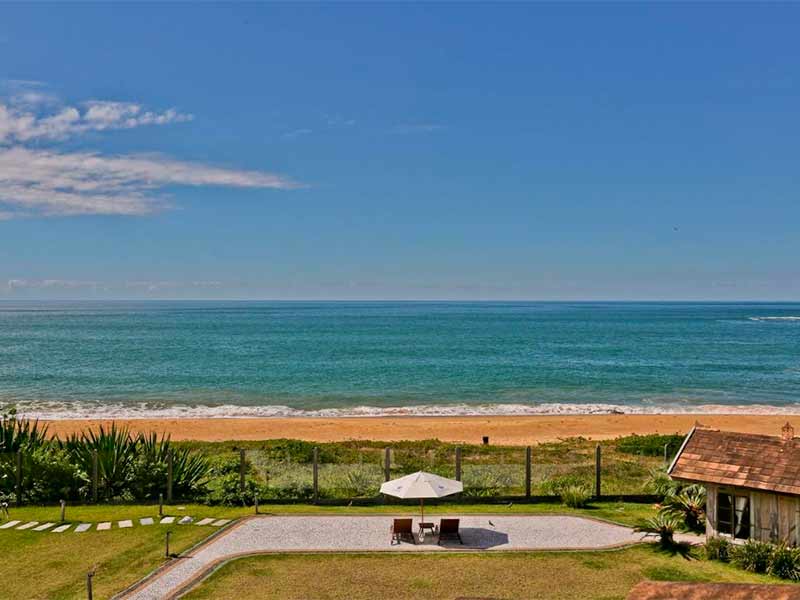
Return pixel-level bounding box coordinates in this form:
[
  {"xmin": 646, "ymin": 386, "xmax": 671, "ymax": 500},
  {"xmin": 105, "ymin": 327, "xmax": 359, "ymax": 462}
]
[{"xmin": 9, "ymin": 402, "xmax": 800, "ymax": 420}]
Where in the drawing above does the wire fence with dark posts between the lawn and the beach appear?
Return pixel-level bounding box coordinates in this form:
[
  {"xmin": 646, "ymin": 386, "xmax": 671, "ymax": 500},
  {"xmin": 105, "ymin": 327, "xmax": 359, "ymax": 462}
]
[{"xmin": 0, "ymin": 440, "xmax": 671, "ymax": 504}]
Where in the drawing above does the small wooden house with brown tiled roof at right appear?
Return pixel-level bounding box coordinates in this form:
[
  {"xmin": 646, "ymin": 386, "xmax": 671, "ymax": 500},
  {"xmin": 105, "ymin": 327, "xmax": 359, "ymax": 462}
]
[{"xmin": 668, "ymin": 423, "xmax": 800, "ymax": 546}]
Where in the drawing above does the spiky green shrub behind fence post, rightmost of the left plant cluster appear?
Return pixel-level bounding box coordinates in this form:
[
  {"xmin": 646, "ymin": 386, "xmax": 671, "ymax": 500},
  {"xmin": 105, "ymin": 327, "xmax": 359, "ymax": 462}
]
[{"xmin": 131, "ymin": 433, "xmax": 210, "ymax": 499}]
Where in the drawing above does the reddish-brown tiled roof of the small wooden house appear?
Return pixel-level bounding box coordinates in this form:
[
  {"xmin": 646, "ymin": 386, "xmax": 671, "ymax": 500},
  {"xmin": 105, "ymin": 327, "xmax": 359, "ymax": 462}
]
[{"xmin": 669, "ymin": 427, "xmax": 800, "ymax": 496}]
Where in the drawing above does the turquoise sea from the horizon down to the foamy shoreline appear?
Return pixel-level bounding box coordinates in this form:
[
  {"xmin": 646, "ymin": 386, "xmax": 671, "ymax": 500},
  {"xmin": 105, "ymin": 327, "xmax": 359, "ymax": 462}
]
[{"xmin": 0, "ymin": 302, "xmax": 800, "ymax": 417}]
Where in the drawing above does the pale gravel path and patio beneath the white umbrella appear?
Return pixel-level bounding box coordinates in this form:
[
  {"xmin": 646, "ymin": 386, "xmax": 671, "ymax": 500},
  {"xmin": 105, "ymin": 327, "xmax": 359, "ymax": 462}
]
[{"xmin": 119, "ymin": 515, "xmax": 656, "ymax": 600}]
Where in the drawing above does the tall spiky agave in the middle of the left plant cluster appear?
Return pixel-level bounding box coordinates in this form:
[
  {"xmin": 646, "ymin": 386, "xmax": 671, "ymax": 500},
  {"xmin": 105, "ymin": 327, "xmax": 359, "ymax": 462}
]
[{"xmin": 61, "ymin": 423, "xmax": 136, "ymax": 499}]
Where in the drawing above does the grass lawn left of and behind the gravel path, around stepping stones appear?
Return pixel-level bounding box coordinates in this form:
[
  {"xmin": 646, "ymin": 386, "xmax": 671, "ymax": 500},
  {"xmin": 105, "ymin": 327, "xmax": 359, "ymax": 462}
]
[{"xmin": 0, "ymin": 502, "xmax": 655, "ymax": 600}]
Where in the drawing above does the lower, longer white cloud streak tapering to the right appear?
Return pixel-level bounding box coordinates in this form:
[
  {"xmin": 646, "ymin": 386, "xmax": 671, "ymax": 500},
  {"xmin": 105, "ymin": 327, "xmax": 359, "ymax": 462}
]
[{"xmin": 0, "ymin": 146, "xmax": 297, "ymax": 216}]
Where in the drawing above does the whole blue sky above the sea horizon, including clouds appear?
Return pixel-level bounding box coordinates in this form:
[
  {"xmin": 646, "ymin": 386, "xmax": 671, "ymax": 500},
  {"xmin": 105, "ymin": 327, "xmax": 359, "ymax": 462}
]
[{"xmin": 0, "ymin": 4, "xmax": 800, "ymax": 300}]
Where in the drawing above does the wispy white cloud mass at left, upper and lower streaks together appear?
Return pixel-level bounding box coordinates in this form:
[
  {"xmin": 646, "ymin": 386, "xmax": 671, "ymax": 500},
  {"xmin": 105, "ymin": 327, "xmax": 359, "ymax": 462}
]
[{"xmin": 0, "ymin": 80, "xmax": 298, "ymax": 220}]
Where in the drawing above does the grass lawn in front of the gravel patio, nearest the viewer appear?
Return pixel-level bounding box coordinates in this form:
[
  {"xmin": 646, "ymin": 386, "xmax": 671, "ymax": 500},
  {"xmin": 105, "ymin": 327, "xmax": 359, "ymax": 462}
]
[{"xmin": 186, "ymin": 545, "xmax": 785, "ymax": 600}]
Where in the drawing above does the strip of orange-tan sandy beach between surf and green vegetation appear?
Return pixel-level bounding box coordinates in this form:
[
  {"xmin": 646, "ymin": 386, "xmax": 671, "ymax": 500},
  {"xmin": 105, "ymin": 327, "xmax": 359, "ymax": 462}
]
[{"xmin": 40, "ymin": 414, "xmax": 800, "ymax": 445}]
